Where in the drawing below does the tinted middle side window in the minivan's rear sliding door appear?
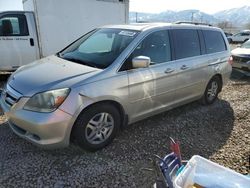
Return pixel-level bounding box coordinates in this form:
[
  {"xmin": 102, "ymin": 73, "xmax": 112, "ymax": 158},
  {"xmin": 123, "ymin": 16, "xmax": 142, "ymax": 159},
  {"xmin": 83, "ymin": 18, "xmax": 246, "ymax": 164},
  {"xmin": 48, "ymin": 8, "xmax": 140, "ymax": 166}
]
[{"xmin": 173, "ymin": 29, "xmax": 201, "ymax": 59}]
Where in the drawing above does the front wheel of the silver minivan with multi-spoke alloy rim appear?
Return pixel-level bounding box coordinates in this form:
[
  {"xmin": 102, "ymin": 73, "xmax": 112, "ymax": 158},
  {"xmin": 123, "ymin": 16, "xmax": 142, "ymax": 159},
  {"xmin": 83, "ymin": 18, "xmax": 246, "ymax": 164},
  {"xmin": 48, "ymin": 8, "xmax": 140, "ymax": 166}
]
[{"xmin": 72, "ymin": 104, "xmax": 121, "ymax": 151}]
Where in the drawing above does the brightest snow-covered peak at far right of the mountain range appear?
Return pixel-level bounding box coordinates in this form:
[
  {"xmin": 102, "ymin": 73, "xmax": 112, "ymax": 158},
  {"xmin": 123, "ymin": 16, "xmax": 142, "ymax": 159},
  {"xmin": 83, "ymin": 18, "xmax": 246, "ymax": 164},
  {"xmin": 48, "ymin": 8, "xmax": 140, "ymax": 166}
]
[{"xmin": 214, "ymin": 6, "xmax": 250, "ymax": 25}]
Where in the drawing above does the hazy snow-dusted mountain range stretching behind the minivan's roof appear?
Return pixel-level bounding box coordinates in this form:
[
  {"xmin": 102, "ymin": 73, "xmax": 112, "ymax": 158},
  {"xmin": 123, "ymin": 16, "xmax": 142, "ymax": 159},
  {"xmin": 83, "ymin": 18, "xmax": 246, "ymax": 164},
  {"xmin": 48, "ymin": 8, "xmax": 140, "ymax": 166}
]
[{"xmin": 129, "ymin": 6, "xmax": 250, "ymax": 26}]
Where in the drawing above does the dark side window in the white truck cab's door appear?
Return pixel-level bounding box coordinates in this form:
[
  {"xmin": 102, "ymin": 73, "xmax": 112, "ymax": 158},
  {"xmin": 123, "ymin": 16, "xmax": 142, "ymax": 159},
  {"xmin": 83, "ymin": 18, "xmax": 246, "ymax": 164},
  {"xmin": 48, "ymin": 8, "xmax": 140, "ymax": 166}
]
[{"xmin": 0, "ymin": 15, "xmax": 29, "ymax": 36}]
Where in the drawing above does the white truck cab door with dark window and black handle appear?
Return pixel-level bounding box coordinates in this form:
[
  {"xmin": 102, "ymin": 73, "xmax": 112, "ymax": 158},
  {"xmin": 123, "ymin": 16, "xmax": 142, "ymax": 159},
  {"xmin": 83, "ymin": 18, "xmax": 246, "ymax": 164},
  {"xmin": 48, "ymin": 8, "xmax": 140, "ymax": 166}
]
[{"xmin": 0, "ymin": 13, "xmax": 39, "ymax": 71}]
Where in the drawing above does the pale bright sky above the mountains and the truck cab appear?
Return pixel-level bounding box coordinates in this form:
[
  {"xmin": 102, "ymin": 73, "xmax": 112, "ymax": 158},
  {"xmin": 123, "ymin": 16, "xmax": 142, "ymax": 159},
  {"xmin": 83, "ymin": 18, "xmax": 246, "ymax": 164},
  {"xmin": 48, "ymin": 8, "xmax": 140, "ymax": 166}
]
[{"xmin": 0, "ymin": 0, "xmax": 250, "ymax": 13}]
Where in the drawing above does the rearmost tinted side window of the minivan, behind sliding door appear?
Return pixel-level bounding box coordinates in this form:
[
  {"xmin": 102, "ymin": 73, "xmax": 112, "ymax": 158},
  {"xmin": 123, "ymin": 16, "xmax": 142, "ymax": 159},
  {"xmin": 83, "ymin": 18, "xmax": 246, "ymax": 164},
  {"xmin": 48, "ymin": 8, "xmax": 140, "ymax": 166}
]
[{"xmin": 202, "ymin": 30, "xmax": 227, "ymax": 54}]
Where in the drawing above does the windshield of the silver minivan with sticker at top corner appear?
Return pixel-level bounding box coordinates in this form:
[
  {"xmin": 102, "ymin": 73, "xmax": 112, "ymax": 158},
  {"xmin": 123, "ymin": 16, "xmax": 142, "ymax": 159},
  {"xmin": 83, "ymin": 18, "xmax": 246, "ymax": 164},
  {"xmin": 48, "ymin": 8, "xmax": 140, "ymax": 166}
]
[{"xmin": 59, "ymin": 29, "xmax": 138, "ymax": 69}]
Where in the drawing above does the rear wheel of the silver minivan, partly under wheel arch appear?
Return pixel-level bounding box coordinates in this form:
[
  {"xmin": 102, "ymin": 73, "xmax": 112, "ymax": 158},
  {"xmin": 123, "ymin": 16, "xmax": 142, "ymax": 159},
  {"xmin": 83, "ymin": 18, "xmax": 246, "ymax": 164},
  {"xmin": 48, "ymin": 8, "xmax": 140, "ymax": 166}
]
[{"xmin": 201, "ymin": 76, "xmax": 222, "ymax": 105}]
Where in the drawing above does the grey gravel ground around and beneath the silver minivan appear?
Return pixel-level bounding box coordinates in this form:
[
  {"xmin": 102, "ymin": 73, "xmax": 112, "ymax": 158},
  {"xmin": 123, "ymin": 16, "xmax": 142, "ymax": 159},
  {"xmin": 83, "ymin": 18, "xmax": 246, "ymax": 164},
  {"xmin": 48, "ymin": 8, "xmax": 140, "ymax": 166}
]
[{"xmin": 0, "ymin": 71, "xmax": 250, "ymax": 188}]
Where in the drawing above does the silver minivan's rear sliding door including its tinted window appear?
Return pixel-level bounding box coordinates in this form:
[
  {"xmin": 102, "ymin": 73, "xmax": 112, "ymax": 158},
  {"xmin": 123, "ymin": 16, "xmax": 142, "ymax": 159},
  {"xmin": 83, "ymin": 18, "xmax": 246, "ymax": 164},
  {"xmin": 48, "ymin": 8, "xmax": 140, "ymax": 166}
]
[{"xmin": 171, "ymin": 29, "xmax": 207, "ymax": 104}]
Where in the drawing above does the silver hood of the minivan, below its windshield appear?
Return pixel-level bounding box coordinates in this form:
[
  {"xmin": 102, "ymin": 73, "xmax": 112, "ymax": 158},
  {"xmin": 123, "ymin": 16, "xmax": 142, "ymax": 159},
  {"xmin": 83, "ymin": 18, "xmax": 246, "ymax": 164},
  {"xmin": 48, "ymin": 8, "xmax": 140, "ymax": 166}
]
[{"xmin": 8, "ymin": 56, "xmax": 101, "ymax": 96}]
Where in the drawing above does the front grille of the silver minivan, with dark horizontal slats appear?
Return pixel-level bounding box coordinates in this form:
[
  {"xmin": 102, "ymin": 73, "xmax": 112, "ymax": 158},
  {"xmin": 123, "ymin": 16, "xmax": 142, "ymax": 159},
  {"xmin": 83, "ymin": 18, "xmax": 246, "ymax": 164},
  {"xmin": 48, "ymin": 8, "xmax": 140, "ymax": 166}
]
[{"xmin": 2, "ymin": 85, "xmax": 22, "ymax": 106}]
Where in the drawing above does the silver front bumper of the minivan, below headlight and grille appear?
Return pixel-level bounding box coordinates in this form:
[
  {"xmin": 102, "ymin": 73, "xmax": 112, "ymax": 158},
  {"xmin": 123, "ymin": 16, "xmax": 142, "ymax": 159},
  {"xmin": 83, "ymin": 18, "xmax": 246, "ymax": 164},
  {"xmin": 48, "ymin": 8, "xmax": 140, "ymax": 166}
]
[{"xmin": 0, "ymin": 88, "xmax": 73, "ymax": 148}]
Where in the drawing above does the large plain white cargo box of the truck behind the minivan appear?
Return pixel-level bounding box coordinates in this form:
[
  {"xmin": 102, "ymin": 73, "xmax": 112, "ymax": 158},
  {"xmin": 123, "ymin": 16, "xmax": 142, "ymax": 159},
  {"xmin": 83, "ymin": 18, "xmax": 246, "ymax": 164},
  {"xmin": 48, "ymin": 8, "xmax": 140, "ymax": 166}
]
[{"xmin": 23, "ymin": 0, "xmax": 129, "ymax": 57}]
